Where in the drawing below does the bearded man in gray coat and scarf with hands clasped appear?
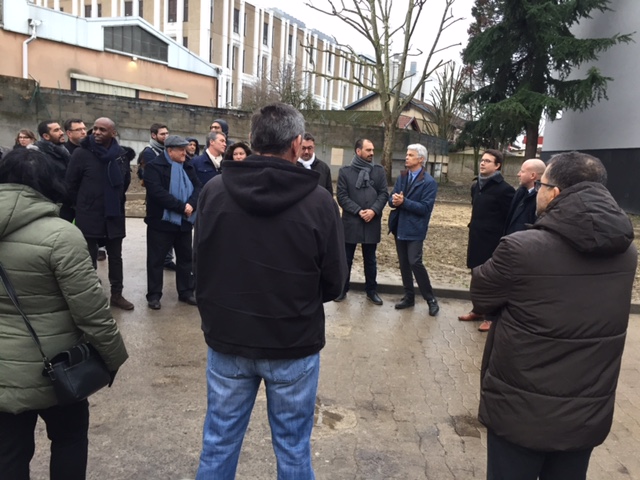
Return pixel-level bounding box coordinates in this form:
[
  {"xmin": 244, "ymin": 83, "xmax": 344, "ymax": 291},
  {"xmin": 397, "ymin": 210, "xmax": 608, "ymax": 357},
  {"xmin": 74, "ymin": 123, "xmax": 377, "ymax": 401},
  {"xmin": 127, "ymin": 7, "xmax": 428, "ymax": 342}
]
[{"xmin": 335, "ymin": 138, "xmax": 389, "ymax": 305}]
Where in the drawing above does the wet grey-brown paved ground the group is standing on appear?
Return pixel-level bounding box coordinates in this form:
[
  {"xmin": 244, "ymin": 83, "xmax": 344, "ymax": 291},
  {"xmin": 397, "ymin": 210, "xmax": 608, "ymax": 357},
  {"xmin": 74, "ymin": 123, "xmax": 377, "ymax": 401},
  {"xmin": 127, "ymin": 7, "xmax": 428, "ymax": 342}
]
[{"xmin": 28, "ymin": 219, "xmax": 640, "ymax": 480}]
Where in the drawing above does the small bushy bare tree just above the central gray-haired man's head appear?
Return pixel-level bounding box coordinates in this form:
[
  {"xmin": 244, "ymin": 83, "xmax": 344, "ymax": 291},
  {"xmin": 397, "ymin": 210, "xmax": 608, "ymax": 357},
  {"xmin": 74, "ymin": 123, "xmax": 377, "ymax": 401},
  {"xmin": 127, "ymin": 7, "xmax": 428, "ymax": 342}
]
[{"xmin": 241, "ymin": 63, "xmax": 319, "ymax": 111}]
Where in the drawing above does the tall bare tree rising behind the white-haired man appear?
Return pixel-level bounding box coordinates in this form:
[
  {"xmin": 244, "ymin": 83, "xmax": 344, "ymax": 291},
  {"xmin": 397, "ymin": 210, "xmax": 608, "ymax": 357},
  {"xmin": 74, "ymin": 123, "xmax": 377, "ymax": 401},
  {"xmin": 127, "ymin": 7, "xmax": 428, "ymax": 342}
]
[{"xmin": 306, "ymin": 0, "xmax": 460, "ymax": 182}]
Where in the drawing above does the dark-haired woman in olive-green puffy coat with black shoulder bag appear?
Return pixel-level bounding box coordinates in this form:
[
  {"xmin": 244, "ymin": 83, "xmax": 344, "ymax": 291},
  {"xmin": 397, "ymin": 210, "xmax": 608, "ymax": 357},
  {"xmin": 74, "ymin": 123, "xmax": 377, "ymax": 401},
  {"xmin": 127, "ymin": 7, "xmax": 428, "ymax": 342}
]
[{"xmin": 0, "ymin": 148, "xmax": 127, "ymax": 480}]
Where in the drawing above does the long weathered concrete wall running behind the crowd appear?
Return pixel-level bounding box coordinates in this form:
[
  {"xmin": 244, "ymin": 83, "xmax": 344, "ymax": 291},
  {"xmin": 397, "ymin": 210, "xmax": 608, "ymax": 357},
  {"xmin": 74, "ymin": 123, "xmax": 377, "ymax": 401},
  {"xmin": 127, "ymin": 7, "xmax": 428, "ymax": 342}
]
[{"xmin": 0, "ymin": 76, "xmax": 446, "ymax": 178}]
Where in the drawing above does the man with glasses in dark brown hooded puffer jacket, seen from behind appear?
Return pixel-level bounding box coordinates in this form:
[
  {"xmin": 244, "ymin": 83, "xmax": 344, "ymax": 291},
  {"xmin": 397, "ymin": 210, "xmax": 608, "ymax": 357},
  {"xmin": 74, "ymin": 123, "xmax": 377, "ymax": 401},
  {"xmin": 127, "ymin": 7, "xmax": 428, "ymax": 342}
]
[{"xmin": 471, "ymin": 152, "xmax": 637, "ymax": 480}]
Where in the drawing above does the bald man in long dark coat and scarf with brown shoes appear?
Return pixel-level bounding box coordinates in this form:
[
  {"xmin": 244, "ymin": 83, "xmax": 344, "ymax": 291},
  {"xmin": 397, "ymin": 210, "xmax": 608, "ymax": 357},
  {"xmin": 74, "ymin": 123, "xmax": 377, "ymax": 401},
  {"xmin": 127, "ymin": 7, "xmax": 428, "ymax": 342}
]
[{"xmin": 65, "ymin": 117, "xmax": 135, "ymax": 310}]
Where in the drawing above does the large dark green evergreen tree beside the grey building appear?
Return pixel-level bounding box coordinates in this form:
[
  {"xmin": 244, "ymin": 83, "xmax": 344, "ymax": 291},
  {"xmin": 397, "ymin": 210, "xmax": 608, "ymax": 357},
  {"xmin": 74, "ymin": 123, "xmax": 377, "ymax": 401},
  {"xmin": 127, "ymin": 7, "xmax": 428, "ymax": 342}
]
[{"xmin": 463, "ymin": 0, "xmax": 631, "ymax": 158}]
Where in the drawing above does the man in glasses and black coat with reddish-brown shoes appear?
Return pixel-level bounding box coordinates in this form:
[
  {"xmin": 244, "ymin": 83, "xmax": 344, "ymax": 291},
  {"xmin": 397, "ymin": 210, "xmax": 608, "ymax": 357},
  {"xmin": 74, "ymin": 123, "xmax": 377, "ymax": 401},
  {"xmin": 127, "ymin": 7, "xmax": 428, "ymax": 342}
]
[{"xmin": 458, "ymin": 150, "xmax": 515, "ymax": 332}]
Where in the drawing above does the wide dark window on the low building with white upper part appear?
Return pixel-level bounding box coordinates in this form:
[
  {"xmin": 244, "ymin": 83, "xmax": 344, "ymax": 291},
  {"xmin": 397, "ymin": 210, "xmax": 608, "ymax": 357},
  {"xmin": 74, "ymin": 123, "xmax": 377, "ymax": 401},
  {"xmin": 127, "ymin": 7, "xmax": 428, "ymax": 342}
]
[{"xmin": 104, "ymin": 25, "xmax": 168, "ymax": 62}]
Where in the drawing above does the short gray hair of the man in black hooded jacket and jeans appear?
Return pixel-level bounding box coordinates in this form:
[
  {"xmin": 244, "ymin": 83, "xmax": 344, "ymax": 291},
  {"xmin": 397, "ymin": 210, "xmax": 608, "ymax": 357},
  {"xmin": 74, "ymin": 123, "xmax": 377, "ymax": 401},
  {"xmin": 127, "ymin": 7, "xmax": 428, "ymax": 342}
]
[{"xmin": 251, "ymin": 103, "xmax": 304, "ymax": 155}]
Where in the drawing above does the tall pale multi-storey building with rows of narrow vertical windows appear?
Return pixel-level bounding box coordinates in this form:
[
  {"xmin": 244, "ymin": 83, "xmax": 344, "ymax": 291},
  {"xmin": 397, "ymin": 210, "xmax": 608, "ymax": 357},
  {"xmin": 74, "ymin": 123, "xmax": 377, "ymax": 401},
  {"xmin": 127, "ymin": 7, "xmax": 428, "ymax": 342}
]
[{"xmin": 36, "ymin": 0, "xmax": 375, "ymax": 109}]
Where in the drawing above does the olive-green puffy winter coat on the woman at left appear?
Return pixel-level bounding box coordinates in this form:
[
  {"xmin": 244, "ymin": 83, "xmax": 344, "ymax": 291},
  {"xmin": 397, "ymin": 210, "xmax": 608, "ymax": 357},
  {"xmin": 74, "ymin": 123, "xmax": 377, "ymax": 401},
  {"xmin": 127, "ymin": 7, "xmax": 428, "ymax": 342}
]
[{"xmin": 0, "ymin": 184, "xmax": 127, "ymax": 414}]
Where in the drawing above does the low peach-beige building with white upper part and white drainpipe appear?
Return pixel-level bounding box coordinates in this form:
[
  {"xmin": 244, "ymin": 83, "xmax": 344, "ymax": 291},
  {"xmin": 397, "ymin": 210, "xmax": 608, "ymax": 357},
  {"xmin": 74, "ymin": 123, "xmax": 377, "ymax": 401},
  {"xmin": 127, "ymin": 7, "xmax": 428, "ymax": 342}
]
[{"xmin": 0, "ymin": 0, "xmax": 218, "ymax": 106}]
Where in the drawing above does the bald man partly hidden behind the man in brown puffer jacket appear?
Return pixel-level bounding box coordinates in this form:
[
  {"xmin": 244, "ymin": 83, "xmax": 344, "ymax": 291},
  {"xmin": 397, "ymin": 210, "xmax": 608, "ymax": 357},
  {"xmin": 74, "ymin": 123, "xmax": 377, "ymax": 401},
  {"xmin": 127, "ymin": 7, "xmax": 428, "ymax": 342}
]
[{"xmin": 504, "ymin": 158, "xmax": 546, "ymax": 235}]
